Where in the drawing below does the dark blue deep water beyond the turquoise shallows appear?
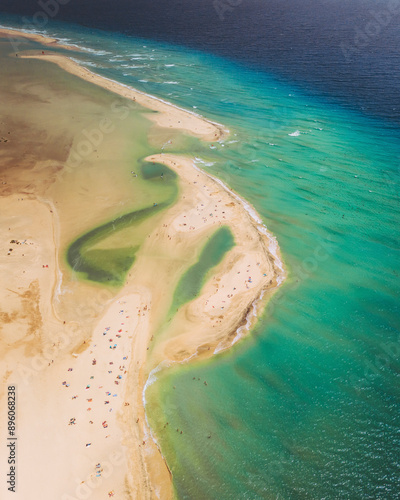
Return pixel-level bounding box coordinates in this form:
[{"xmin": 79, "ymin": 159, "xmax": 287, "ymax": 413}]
[{"xmin": 0, "ymin": 0, "xmax": 400, "ymax": 123}]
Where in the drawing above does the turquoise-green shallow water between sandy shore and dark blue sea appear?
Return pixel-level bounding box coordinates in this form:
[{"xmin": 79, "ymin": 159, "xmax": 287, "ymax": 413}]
[{"xmin": 3, "ymin": 15, "xmax": 400, "ymax": 500}]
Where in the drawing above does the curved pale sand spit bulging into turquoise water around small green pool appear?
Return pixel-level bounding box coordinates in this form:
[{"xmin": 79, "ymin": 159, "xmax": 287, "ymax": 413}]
[{"xmin": 141, "ymin": 154, "xmax": 282, "ymax": 370}]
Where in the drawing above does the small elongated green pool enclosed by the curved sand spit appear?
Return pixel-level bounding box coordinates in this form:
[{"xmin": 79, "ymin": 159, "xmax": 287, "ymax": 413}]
[{"xmin": 170, "ymin": 226, "xmax": 235, "ymax": 315}]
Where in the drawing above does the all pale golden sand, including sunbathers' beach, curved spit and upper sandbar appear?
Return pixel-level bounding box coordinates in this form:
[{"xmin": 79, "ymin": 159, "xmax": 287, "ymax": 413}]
[{"xmin": 0, "ymin": 29, "xmax": 283, "ymax": 500}]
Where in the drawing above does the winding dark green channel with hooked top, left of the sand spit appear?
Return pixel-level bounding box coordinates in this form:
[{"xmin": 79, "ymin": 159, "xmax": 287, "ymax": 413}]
[{"xmin": 66, "ymin": 162, "xmax": 178, "ymax": 286}]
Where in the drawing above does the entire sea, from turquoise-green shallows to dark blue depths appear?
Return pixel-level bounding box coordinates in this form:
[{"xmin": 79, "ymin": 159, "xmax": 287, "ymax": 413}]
[{"xmin": 0, "ymin": 0, "xmax": 400, "ymax": 500}]
